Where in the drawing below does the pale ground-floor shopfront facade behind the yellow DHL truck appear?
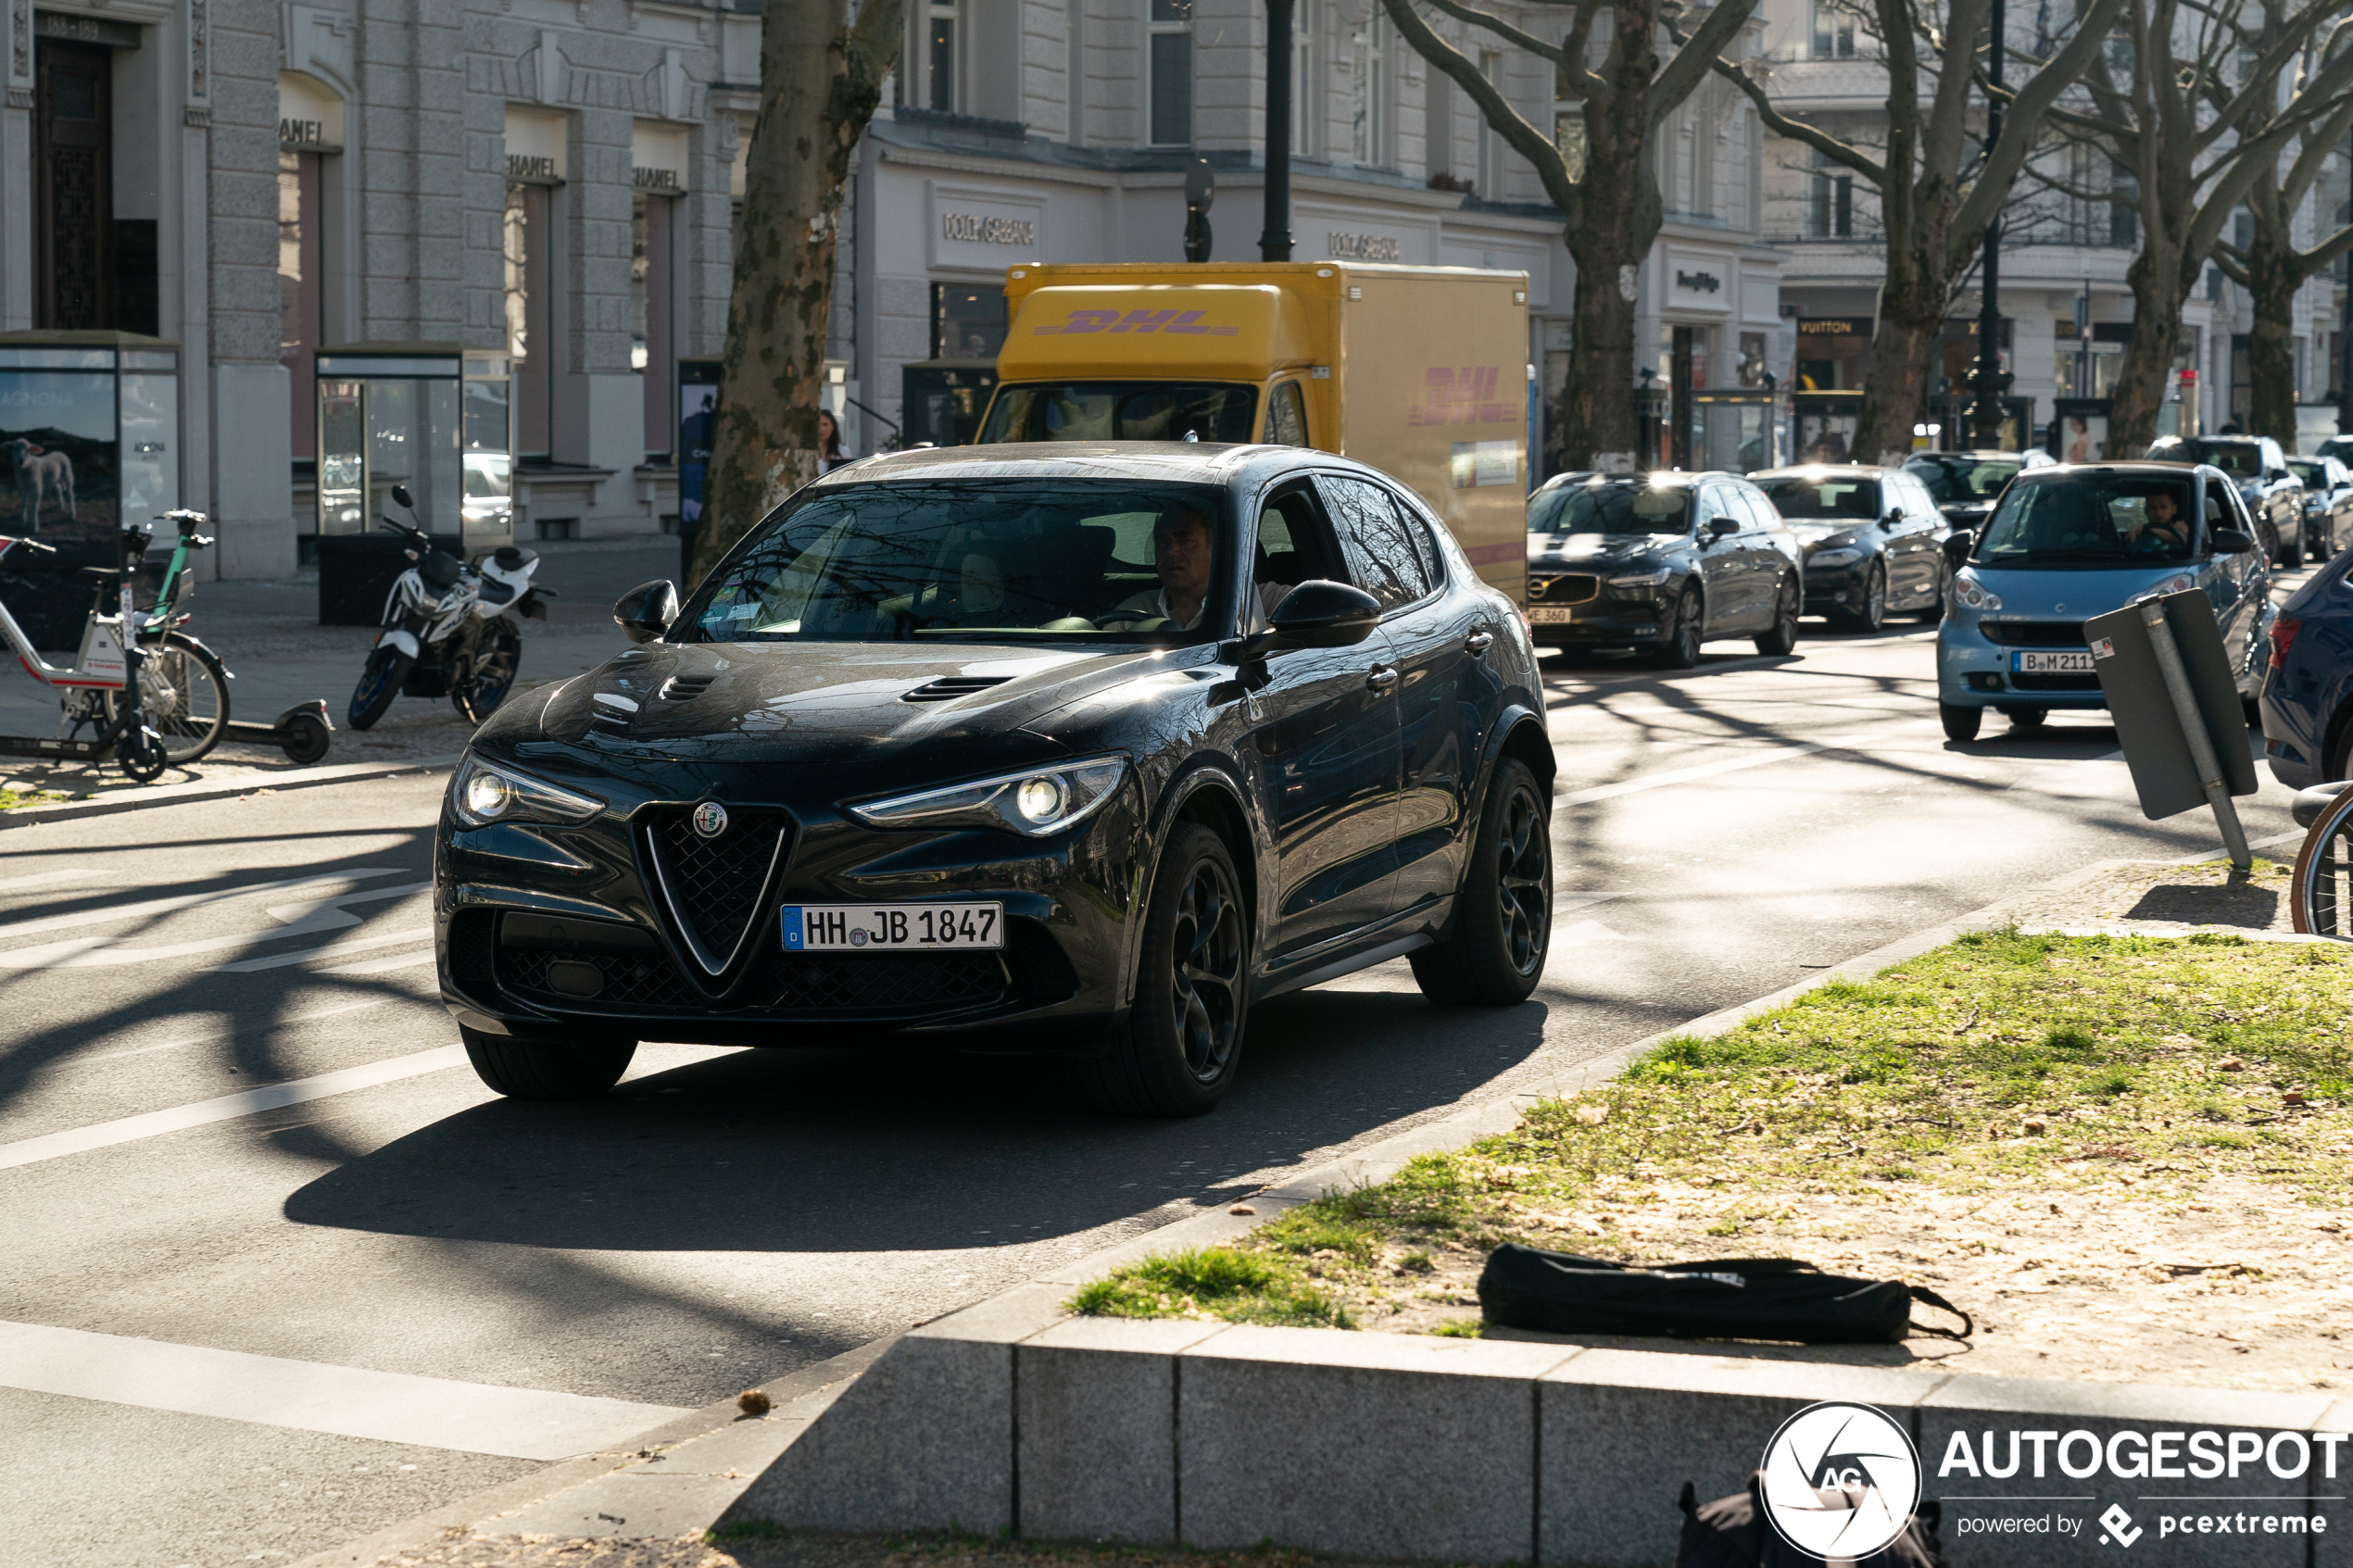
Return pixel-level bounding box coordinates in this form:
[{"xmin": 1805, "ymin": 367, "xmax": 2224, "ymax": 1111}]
[{"xmin": 828, "ymin": 115, "xmax": 1569, "ymax": 456}]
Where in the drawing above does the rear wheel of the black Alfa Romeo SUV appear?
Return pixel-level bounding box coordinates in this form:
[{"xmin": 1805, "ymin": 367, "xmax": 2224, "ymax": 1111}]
[{"xmin": 1412, "ymin": 757, "xmax": 1553, "ymax": 1006}]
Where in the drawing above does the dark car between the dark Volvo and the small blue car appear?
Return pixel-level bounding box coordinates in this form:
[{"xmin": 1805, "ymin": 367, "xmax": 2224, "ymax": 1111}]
[{"xmin": 1748, "ymin": 463, "xmax": 1951, "ymax": 633}]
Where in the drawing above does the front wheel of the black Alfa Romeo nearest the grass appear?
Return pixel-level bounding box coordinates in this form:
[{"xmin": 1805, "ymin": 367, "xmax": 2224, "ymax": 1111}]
[{"xmin": 1082, "ymin": 822, "xmax": 1250, "ymax": 1117}]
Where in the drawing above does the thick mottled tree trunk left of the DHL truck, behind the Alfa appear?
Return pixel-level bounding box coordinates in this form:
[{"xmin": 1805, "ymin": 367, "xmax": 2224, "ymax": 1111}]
[{"xmin": 694, "ymin": 0, "xmax": 903, "ymax": 581}]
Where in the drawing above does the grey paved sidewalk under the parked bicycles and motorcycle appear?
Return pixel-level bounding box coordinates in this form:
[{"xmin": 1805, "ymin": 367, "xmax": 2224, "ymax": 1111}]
[{"xmin": 0, "ymin": 536, "xmax": 678, "ymax": 797}]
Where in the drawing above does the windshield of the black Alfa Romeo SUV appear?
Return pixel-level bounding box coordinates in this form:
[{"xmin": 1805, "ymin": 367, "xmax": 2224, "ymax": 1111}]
[{"xmin": 680, "ymin": 480, "xmax": 1228, "ymax": 642}]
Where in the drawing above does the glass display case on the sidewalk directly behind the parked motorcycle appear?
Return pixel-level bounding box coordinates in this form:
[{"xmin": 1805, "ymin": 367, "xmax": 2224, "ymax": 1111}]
[{"xmin": 313, "ymin": 344, "xmax": 515, "ymax": 625}]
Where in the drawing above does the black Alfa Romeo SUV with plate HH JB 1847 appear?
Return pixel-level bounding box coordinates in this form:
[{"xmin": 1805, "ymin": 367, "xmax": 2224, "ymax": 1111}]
[{"xmin": 435, "ymin": 442, "xmax": 1553, "ymax": 1117}]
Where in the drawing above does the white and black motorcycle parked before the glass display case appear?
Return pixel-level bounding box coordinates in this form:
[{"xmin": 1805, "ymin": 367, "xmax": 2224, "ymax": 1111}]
[{"xmin": 350, "ymin": 484, "xmax": 558, "ymax": 729}]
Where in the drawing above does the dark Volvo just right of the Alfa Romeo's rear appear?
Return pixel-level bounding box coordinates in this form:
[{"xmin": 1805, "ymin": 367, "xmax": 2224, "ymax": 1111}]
[{"xmin": 1527, "ymin": 472, "xmax": 1800, "ymax": 670}]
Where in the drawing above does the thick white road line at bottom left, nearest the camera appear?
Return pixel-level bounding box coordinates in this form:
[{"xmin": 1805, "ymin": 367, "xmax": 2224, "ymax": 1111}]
[{"xmin": 0, "ymin": 1321, "xmax": 687, "ymax": 1460}]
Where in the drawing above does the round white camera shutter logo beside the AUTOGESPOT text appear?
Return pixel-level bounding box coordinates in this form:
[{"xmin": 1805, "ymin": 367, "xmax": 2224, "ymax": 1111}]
[{"xmin": 1762, "ymin": 1403, "xmax": 1920, "ymax": 1559}]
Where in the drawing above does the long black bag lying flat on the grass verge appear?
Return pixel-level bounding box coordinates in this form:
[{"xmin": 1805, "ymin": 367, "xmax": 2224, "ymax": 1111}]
[{"xmin": 1478, "ymin": 1241, "xmax": 1974, "ymax": 1345}]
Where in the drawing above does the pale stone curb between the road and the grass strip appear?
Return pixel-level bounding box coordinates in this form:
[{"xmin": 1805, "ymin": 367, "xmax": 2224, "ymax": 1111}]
[{"xmin": 292, "ymin": 832, "xmax": 2304, "ymax": 1568}]
